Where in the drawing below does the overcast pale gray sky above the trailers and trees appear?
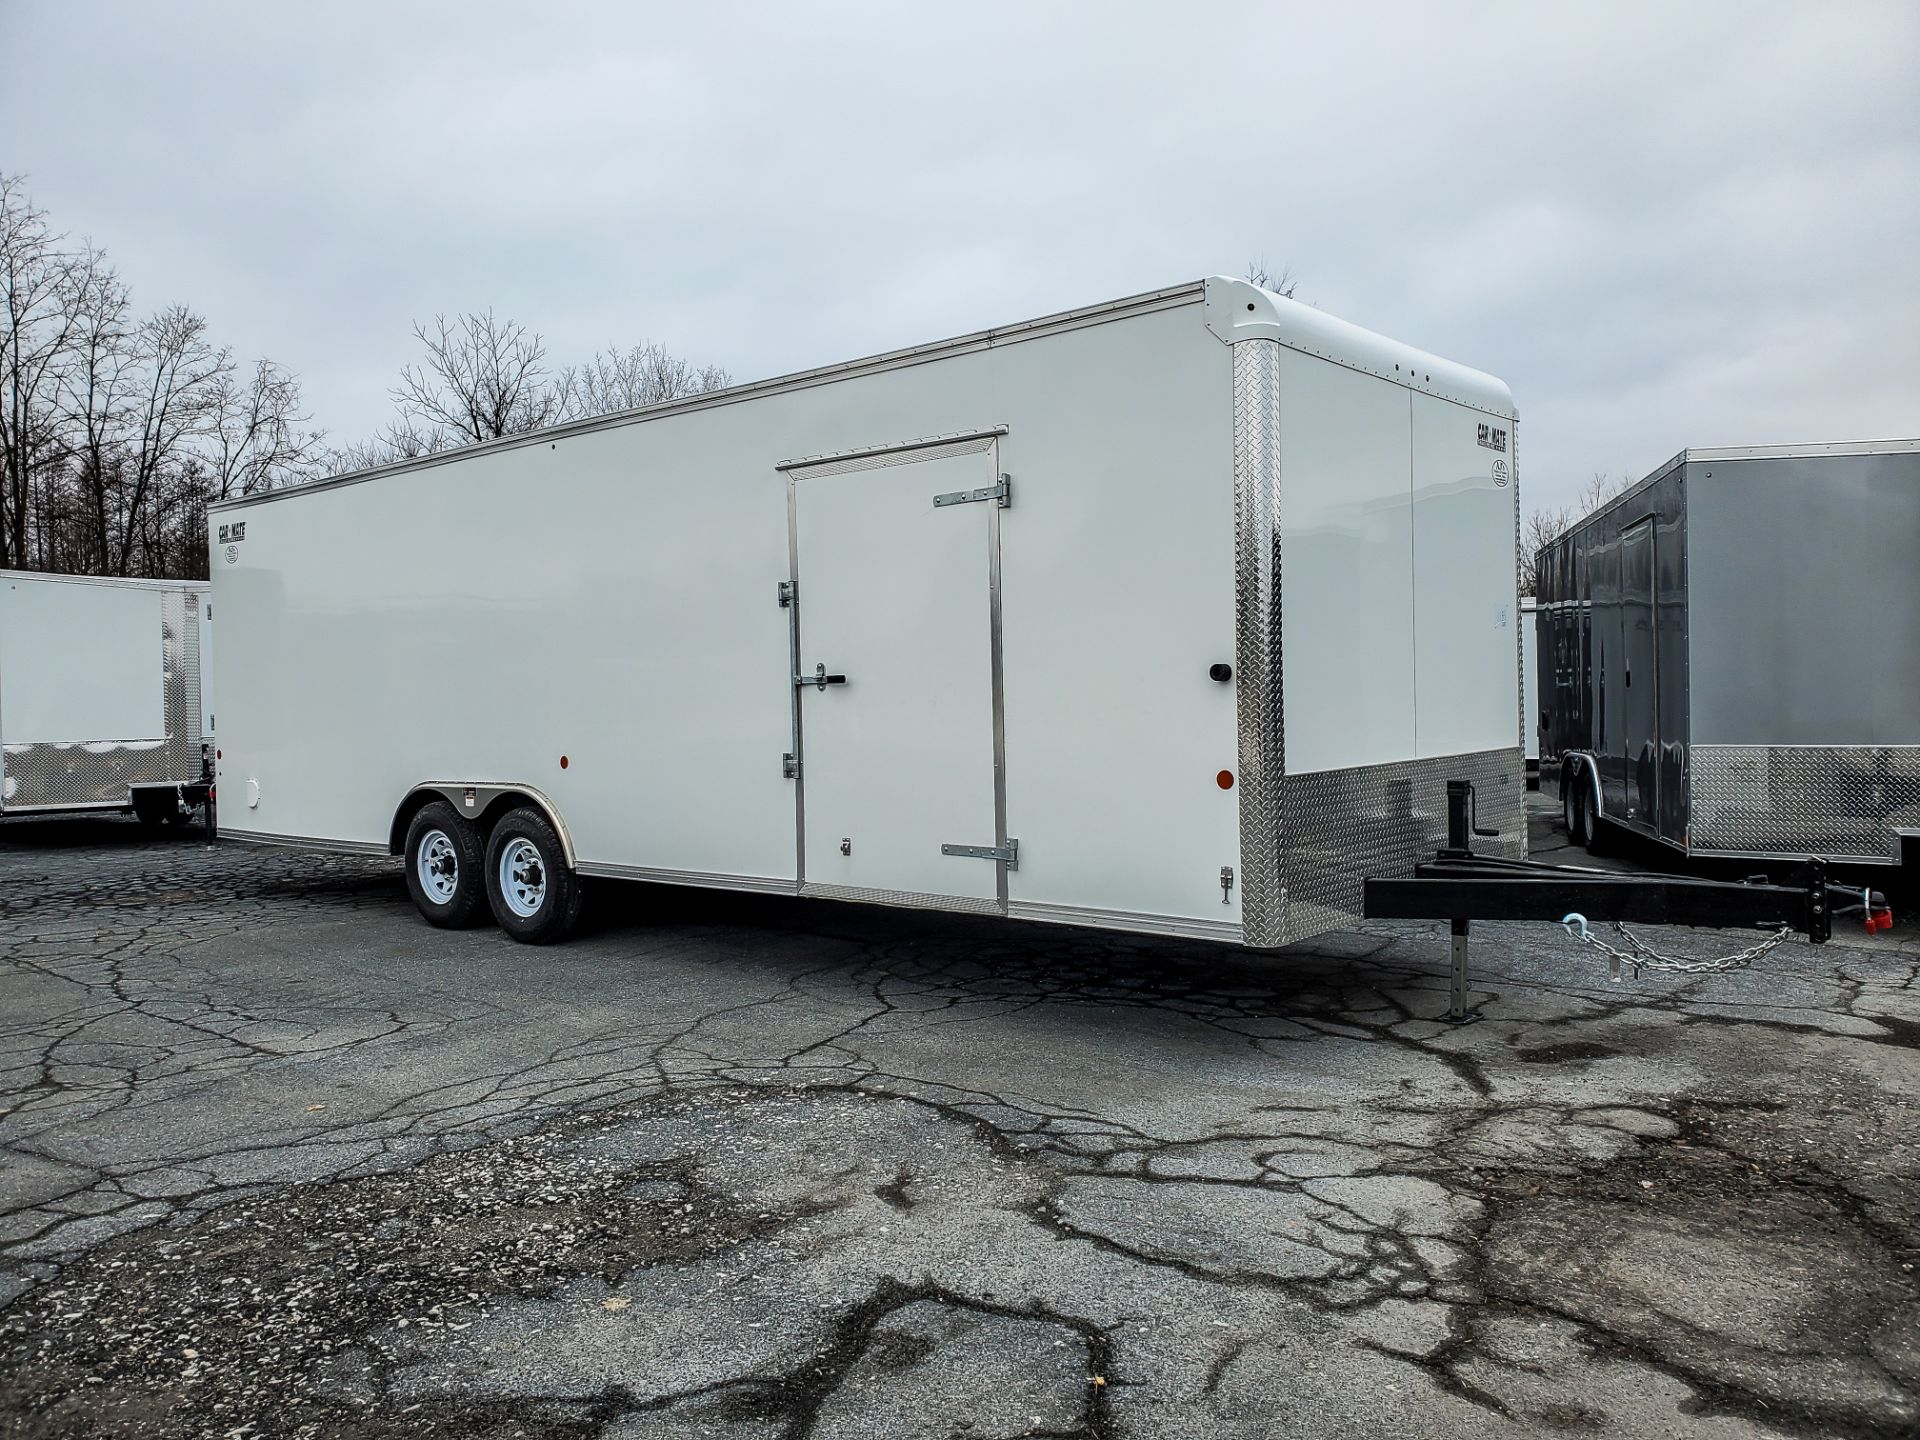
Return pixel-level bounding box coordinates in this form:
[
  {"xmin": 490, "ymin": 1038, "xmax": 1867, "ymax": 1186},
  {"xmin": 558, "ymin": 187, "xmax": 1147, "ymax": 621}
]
[{"xmin": 0, "ymin": 0, "xmax": 1920, "ymax": 503}]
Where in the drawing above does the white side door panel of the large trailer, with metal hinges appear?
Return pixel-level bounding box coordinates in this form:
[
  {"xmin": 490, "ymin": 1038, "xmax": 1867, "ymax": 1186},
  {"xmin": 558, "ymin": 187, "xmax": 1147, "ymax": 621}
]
[{"xmin": 795, "ymin": 451, "xmax": 998, "ymax": 900}]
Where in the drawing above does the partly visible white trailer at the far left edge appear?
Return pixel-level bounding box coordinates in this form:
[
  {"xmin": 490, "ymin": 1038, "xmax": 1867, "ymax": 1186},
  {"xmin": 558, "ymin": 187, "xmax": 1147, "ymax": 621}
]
[{"xmin": 0, "ymin": 570, "xmax": 213, "ymax": 822}]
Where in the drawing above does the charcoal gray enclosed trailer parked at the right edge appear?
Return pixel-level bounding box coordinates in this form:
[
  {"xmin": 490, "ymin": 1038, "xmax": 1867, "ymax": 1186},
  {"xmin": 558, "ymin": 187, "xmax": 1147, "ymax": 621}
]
[{"xmin": 1538, "ymin": 440, "xmax": 1920, "ymax": 864}]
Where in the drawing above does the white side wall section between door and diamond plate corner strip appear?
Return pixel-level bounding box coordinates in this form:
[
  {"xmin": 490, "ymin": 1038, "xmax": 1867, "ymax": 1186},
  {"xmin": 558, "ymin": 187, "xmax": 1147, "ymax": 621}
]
[{"xmin": 1000, "ymin": 305, "xmax": 1240, "ymax": 924}]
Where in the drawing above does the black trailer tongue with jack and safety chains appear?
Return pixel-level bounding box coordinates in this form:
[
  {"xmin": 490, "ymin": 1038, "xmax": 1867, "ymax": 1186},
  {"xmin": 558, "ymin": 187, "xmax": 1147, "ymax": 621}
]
[{"xmin": 1363, "ymin": 780, "xmax": 1891, "ymax": 1020}]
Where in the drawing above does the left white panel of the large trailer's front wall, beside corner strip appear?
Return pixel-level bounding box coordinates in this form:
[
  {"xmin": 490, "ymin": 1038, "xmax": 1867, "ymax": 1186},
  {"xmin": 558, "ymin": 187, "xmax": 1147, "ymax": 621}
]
[{"xmin": 1281, "ymin": 349, "xmax": 1420, "ymax": 774}]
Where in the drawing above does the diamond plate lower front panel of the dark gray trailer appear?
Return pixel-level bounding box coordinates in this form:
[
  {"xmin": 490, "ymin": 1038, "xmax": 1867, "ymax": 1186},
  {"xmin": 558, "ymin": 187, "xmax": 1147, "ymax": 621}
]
[{"xmin": 1688, "ymin": 745, "xmax": 1920, "ymax": 860}]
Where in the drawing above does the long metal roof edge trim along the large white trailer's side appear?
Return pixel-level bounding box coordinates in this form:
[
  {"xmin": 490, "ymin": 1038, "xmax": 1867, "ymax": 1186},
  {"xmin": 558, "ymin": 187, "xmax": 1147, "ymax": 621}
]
[{"xmin": 207, "ymin": 280, "xmax": 1206, "ymax": 515}]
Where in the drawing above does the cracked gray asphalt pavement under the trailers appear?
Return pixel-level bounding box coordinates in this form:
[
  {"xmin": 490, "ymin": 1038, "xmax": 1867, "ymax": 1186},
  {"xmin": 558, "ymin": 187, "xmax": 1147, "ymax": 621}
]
[{"xmin": 0, "ymin": 820, "xmax": 1920, "ymax": 1440}]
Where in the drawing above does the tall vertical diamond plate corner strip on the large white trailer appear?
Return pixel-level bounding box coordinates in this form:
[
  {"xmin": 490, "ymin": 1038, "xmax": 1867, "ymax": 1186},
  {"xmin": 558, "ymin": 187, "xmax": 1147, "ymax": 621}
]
[{"xmin": 1233, "ymin": 340, "xmax": 1286, "ymax": 948}]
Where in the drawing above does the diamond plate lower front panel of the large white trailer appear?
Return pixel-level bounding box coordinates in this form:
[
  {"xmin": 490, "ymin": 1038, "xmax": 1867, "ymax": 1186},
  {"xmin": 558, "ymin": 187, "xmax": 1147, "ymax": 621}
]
[{"xmin": 1279, "ymin": 747, "xmax": 1526, "ymax": 945}]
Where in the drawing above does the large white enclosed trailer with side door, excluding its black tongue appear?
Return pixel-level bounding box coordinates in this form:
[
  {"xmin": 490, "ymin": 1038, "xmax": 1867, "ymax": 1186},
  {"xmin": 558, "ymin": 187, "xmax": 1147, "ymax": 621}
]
[{"xmin": 209, "ymin": 278, "xmax": 1524, "ymax": 947}]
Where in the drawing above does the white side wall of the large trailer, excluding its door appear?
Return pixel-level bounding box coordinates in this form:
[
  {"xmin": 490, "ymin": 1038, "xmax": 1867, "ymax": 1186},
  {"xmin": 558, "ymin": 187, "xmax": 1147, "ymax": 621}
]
[{"xmin": 215, "ymin": 294, "xmax": 1238, "ymax": 922}]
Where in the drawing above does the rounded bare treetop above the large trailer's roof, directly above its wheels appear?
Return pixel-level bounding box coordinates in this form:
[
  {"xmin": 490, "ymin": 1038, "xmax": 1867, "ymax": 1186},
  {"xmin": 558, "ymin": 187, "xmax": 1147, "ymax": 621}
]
[{"xmin": 394, "ymin": 309, "xmax": 559, "ymax": 442}]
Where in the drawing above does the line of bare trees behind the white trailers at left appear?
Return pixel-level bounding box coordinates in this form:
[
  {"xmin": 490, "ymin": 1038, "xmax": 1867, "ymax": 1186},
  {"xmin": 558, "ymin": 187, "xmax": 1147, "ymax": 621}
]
[{"xmin": 0, "ymin": 173, "xmax": 728, "ymax": 578}]
